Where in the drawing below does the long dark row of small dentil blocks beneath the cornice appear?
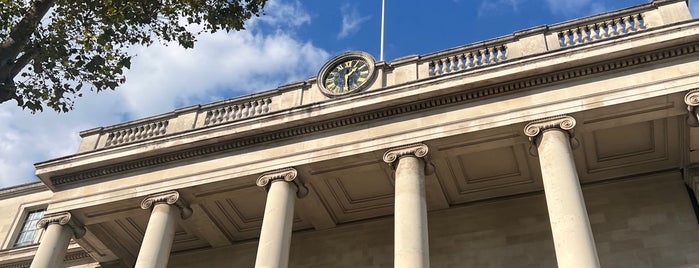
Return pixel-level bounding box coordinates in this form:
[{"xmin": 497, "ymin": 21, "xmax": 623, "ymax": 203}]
[{"xmin": 50, "ymin": 43, "xmax": 699, "ymax": 187}]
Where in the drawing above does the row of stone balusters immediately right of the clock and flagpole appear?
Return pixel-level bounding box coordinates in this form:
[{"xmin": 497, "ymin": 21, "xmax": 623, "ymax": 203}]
[{"xmin": 429, "ymin": 45, "xmax": 507, "ymax": 76}]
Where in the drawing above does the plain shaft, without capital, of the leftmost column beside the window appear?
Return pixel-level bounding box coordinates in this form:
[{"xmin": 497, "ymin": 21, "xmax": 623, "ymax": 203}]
[{"xmin": 31, "ymin": 224, "xmax": 73, "ymax": 268}]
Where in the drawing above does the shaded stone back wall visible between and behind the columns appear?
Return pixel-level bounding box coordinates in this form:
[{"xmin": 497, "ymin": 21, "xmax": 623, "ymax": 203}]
[{"xmin": 170, "ymin": 172, "xmax": 699, "ymax": 267}]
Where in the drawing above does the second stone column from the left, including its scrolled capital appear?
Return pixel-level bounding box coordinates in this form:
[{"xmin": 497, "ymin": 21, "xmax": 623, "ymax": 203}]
[{"xmin": 135, "ymin": 191, "xmax": 192, "ymax": 268}]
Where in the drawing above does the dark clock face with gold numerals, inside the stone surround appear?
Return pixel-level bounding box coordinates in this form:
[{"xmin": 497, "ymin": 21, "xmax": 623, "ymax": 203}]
[{"xmin": 323, "ymin": 59, "xmax": 370, "ymax": 95}]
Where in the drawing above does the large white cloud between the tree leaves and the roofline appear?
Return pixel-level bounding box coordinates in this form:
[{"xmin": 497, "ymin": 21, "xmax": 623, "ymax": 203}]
[{"xmin": 0, "ymin": 1, "xmax": 329, "ymax": 188}]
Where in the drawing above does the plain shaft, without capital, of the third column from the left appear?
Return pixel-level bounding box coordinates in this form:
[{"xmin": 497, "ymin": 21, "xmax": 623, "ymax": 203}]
[{"xmin": 255, "ymin": 180, "xmax": 297, "ymax": 268}]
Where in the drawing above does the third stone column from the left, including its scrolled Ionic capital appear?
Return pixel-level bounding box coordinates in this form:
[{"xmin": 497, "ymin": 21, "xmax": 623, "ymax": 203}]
[{"xmin": 255, "ymin": 168, "xmax": 308, "ymax": 268}]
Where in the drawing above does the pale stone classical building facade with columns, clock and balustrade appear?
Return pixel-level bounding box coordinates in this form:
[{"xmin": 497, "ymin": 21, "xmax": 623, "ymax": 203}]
[{"xmin": 0, "ymin": 0, "xmax": 699, "ymax": 267}]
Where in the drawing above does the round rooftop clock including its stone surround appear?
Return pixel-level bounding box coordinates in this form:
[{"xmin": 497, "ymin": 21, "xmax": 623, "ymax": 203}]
[{"xmin": 318, "ymin": 51, "xmax": 374, "ymax": 97}]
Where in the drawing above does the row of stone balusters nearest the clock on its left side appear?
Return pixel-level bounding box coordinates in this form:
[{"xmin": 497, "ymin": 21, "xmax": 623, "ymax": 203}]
[{"xmin": 204, "ymin": 97, "xmax": 272, "ymax": 126}]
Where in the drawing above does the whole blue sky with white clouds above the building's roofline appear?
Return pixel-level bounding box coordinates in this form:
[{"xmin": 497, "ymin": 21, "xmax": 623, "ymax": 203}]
[{"xmin": 0, "ymin": 0, "xmax": 699, "ymax": 188}]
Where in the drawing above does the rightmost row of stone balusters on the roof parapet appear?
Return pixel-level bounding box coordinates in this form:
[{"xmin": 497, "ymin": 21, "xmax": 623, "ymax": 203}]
[{"xmin": 558, "ymin": 13, "xmax": 646, "ymax": 48}]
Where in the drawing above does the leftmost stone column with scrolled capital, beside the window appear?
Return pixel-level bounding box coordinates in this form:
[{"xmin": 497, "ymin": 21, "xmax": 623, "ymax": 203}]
[{"xmin": 31, "ymin": 212, "xmax": 85, "ymax": 268}]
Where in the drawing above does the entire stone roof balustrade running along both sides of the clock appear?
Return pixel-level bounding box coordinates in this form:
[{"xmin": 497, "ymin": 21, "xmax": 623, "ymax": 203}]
[{"xmin": 79, "ymin": 0, "xmax": 692, "ymax": 152}]
